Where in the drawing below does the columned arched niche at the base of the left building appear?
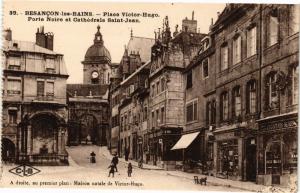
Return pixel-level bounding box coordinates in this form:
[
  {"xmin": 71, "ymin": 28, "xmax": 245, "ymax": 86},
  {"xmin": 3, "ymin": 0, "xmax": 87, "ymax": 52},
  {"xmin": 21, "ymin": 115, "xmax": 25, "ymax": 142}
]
[{"xmin": 17, "ymin": 112, "xmax": 68, "ymax": 165}]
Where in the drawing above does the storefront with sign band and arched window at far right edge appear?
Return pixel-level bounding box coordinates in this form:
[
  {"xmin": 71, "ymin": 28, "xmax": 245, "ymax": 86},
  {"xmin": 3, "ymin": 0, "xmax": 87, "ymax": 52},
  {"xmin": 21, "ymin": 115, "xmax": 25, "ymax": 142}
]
[{"xmin": 257, "ymin": 113, "xmax": 298, "ymax": 186}]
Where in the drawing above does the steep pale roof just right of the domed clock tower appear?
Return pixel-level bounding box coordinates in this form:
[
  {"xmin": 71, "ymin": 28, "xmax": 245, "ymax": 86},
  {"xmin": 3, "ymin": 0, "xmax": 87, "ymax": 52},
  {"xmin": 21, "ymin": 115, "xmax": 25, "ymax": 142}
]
[{"xmin": 127, "ymin": 36, "xmax": 155, "ymax": 62}]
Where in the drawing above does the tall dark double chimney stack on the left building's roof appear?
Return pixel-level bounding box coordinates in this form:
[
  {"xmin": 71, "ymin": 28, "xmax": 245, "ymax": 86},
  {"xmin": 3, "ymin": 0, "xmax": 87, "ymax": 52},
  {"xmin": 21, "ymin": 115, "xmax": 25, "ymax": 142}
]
[{"xmin": 35, "ymin": 26, "xmax": 54, "ymax": 50}]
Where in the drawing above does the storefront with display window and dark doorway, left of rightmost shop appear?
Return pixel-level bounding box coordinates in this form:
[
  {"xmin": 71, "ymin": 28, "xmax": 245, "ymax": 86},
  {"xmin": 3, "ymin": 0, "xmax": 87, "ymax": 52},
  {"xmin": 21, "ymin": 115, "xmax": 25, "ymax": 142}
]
[{"xmin": 213, "ymin": 123, "xmax": 256, "ymax": 181}]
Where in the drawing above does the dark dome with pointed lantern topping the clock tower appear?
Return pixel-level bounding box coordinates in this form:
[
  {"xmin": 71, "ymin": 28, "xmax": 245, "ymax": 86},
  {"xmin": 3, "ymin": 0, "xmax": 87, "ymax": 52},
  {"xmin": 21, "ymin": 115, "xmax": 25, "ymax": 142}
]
[{"xmin": 84, "ymin": 25, "xmax": 111, "ymax": 62}]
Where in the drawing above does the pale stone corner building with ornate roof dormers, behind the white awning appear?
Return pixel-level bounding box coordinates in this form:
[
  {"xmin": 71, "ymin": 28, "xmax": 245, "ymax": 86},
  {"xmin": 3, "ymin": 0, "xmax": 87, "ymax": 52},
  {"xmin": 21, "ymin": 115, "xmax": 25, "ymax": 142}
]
[{"xmin": 148, "ymin": 13, "xmax": 205, "ymax": 169}]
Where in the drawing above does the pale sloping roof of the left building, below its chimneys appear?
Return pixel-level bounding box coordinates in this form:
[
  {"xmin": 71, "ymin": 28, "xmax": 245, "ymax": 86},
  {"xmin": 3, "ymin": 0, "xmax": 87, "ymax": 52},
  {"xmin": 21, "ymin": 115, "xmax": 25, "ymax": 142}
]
[{"xmin": 3, "ymin": 40, "xmax": 62, "ymax": 55}]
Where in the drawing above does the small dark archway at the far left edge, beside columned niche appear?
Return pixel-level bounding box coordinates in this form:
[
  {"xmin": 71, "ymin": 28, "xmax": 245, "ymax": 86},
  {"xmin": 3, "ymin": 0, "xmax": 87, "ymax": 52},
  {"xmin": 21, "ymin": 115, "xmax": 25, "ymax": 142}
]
[{"xmin": 1, "ymin": 138, "xmax": 15, "ymax": 163}]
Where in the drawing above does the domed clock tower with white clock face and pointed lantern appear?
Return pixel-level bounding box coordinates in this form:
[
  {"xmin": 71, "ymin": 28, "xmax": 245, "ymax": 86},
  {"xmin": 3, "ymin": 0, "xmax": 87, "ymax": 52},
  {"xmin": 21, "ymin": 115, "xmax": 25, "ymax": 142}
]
[{"xmin": 82, "ymin": 25, "xmax": 111, "ymax": 84}]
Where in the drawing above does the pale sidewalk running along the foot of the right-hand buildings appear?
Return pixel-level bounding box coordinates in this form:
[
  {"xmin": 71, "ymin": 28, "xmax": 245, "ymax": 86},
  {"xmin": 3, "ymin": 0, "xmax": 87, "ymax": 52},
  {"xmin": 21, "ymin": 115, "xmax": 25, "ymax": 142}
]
[{"xmin": 99, "ymin": 147, "xmax": 296, "ymax": 193}]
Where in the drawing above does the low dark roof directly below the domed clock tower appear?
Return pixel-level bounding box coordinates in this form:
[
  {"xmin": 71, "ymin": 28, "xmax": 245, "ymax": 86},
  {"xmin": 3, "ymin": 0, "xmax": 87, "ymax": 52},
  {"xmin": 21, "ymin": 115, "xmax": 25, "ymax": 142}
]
[{"xmin": 67, "ymin": 84, "xmax": 108, "ymax": 96}]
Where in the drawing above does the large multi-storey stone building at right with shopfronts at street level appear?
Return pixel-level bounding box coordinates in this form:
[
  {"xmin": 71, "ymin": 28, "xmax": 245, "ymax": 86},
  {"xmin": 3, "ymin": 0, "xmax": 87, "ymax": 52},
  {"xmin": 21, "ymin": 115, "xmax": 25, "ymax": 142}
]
[{"xmin": 185, "ymin": 4, "xmax": 299, "ymax": 185}]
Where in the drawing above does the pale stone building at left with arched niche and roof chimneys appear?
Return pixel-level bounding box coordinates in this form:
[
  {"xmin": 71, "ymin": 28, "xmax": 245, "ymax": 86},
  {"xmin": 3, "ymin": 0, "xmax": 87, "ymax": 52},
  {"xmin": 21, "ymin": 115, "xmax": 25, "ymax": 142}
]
[{"xmin": 2, "ymin": 27, "xmax": 68, "ymax": 165}]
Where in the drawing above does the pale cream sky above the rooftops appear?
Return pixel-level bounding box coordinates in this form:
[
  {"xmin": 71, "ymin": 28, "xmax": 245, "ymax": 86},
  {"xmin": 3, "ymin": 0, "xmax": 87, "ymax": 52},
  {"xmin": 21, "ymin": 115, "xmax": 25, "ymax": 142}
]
[{"xmin": 3, "ymin": 1, "xmax": 225, "ymax": 83}]
